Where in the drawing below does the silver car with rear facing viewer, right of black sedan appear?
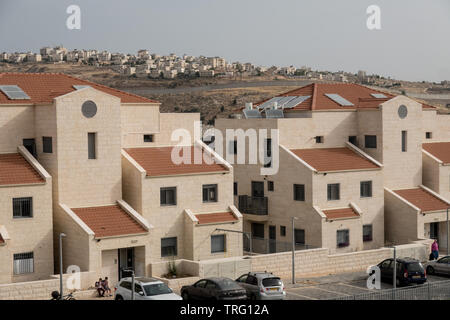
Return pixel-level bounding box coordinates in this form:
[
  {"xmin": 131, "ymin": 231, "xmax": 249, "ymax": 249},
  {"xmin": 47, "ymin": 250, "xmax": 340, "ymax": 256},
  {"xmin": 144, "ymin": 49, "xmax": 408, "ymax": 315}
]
[{"xmin": 236, "ymin": 272, "xmax": 286, "ymax": 300}]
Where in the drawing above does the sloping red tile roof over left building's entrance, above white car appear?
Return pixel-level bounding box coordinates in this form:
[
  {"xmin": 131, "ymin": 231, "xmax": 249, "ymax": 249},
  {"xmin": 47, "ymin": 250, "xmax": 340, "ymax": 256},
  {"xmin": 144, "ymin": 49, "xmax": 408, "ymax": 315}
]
[{"xmin": 72, "ymin": 205, "xmax": 147, "ymax": 238}]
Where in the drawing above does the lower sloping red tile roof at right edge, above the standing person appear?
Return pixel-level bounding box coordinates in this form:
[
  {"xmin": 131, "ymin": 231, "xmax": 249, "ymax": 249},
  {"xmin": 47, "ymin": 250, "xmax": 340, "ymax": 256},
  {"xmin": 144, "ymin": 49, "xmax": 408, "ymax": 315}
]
[{"xmin": 394, "ymin": 188, "xmax": 450, "ymax": 212}]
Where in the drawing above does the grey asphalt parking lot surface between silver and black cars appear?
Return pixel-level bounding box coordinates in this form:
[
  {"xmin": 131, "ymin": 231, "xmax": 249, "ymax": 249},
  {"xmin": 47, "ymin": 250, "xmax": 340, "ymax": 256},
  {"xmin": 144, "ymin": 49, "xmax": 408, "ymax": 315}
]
[{"xmin": 285, "ymin": 272, "xmax": 450, "ymax": 300}]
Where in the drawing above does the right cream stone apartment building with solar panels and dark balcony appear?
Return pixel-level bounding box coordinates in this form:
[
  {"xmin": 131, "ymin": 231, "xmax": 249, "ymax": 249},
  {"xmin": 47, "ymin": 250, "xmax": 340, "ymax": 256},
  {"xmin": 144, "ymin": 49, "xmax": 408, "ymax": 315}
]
[{"xmin": 215, "ymin": 83, "xmax": 450, "ymax": 253}]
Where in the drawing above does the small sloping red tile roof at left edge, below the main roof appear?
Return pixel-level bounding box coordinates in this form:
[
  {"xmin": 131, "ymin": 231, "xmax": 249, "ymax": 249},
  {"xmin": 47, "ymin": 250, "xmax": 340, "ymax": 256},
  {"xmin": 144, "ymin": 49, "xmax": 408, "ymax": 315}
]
[{"xmin": 0, "ymin": 153, "xmax": 45, "ymax": 185}]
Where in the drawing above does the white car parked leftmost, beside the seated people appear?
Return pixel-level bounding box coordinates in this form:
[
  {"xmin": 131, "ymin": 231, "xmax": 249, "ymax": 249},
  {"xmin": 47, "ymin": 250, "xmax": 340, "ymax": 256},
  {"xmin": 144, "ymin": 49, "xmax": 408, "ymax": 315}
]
[{"xmin": 114, "ymin": 277, "xmax": 182, "ymax": 300}]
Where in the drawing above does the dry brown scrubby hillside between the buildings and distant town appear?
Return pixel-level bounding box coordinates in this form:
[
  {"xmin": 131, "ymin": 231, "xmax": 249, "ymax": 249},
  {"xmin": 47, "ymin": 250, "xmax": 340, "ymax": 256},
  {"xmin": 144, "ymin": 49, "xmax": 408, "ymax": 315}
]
[{"xmin": 0, "ymin": 63, "xmax": 450, "ymax": 124}]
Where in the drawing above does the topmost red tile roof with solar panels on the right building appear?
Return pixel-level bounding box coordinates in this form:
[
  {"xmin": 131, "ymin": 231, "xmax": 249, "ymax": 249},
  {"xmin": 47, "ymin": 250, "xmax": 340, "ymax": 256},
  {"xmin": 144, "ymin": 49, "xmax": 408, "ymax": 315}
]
[{"xmin": 255, "ymin": 83, "xmax": 435, "ymax": 112}]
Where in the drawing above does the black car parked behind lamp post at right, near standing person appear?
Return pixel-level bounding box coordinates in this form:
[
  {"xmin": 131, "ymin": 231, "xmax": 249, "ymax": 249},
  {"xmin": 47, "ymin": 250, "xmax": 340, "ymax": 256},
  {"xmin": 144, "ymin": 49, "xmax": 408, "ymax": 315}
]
[{"xmin": 378, "ymin": 258, "xmax": 427, "ymax": 286}]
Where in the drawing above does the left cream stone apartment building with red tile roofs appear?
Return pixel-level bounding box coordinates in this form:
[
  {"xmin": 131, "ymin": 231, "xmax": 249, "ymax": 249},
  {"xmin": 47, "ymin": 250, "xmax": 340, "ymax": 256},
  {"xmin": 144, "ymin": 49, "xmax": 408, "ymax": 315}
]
[{"xmin": 0, "ymin": 73, "xmax": 243, "ymax": 283}]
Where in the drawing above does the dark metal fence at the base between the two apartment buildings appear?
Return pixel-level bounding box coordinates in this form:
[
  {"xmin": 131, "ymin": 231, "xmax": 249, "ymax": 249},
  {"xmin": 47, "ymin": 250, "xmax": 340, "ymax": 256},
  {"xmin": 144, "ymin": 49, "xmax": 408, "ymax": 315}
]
[{"xmin": 243, "ymin": 235, "xmax": 315, "ymax": 254}]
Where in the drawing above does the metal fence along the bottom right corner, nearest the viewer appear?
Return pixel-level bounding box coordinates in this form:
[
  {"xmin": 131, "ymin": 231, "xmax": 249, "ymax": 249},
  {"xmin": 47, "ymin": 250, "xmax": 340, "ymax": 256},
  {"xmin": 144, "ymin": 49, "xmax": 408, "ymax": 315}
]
[{"xmin": 332, "ymin": 280, "xmax": 450, "ymax": 300}]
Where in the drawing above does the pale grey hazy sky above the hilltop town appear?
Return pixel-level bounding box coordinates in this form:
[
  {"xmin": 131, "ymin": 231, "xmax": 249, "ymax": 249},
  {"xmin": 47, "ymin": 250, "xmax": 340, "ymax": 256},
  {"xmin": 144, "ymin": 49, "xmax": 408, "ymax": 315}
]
[{"xmin": 0, "ymin": 0, "xmax": 450, "ymax": 81}]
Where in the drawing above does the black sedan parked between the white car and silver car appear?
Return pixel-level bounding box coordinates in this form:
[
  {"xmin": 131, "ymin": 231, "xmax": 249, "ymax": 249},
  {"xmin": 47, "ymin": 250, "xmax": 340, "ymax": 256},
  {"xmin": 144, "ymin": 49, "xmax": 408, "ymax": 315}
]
[{"xmin": 181, "ymin": 278, "xmax": 247, "ymax": 300}]
